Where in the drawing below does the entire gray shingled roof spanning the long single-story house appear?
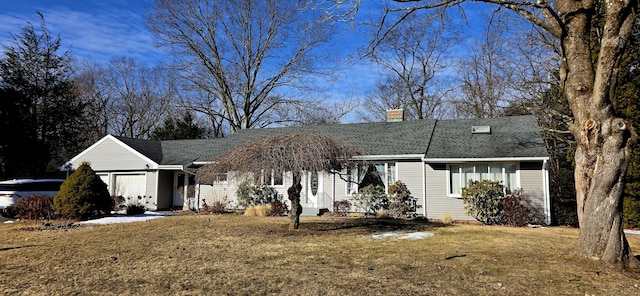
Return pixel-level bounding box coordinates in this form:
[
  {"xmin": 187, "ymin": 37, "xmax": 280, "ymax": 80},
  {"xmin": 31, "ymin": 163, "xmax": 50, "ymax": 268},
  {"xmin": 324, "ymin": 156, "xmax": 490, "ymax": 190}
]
[{"xmin": 112, "ymin": 116, "xmax": 547, "ymax": 165}]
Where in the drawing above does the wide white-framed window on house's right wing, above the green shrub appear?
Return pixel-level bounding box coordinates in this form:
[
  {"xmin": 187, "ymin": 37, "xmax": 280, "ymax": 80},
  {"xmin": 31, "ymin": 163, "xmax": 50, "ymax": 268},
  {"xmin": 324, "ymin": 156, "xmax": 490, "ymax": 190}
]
[{"xmin": 448, "ymin": 163, "xmax": 518, "ymax": 196}]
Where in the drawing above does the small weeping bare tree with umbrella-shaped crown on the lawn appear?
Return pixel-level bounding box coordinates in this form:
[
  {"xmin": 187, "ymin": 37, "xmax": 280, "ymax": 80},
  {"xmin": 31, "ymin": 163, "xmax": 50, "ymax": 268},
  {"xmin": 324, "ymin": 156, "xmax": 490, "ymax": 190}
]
[{"xmin": 197, "ymin": 132, "xmax": 362, "ymax": 229}]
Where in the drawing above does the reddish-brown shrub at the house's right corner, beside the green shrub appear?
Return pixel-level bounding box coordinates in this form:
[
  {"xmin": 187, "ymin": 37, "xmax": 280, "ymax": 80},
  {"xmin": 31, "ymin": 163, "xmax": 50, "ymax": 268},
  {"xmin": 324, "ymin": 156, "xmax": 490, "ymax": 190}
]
[{"xmin": 502, "ymin": 188, "xmax": 542, "ymax": 226}]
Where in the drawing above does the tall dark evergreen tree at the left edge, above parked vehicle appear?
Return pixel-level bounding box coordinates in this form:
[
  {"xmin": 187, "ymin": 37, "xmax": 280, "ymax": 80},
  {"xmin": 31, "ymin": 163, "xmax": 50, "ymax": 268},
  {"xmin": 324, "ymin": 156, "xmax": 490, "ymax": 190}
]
[{"xmin": 0, "ymin": 14, "xmax": 88, "ymax": 178}]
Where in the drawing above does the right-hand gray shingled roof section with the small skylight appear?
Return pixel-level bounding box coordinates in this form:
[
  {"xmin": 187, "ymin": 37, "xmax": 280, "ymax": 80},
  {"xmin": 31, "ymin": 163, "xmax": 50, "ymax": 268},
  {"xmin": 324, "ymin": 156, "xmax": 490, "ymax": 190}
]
[{"xmin": 425, "ymin": 116, "xmax": 548, "ymax": 159}]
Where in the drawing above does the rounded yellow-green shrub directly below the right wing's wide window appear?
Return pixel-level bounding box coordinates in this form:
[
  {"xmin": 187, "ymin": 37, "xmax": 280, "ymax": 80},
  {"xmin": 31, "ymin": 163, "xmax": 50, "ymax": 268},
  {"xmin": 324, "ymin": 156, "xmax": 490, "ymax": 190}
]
[{"xmin": 462, "ymin": 180, "xmax": 504, "ymax": 225}]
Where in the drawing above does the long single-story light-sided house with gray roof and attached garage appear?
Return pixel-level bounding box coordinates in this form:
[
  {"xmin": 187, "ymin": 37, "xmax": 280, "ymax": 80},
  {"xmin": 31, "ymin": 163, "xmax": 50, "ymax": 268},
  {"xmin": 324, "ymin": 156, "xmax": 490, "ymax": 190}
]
[{"xmin": 63, "ymin": 116, "xmax": 551, "ymax": 223}]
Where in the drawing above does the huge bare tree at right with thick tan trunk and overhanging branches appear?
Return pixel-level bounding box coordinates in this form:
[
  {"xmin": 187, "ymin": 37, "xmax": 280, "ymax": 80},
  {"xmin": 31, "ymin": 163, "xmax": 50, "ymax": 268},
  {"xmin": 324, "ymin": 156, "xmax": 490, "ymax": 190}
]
[{"xmin": 344, "ymin": 0, "xmax": 640, "ymax": 271}]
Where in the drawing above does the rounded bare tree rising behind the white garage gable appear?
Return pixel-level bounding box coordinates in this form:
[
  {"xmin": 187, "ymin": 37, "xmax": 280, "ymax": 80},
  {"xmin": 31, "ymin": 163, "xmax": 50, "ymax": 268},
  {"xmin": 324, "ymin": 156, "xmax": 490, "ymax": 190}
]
[{"xmin": 81, "ymin": 57, "xmax": 177, "ymax": 138}]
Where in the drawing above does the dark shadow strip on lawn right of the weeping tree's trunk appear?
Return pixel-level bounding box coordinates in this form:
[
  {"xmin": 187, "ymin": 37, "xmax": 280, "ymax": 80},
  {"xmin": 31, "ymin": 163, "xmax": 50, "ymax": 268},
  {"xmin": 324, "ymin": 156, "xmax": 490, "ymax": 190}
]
[{"xmin": 292, "ymin": 218, "xmax": 453, "ymax": 234}]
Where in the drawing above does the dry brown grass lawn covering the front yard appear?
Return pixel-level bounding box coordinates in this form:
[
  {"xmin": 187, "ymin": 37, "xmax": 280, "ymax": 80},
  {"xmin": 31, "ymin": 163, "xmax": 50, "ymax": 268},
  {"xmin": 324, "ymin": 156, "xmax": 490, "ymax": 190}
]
[{"xmin": 0, "ymin": 215, "xmax": 640, "ymax": 295}]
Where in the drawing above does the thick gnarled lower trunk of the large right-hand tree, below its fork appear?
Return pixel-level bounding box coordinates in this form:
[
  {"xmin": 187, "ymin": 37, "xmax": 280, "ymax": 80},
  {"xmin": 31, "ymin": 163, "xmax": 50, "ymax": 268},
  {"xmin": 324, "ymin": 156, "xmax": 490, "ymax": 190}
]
[{"xmin": 575, "ymin": 118, "xmax": 639, "ymax": 270}]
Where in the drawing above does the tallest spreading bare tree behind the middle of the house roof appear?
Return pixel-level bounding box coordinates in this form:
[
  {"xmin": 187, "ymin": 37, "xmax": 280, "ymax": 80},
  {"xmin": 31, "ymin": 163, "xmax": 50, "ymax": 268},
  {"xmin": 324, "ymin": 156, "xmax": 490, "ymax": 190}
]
[{"xmin": 147, "ymin": 0, "xmax": 333, "ymax": 133}]
